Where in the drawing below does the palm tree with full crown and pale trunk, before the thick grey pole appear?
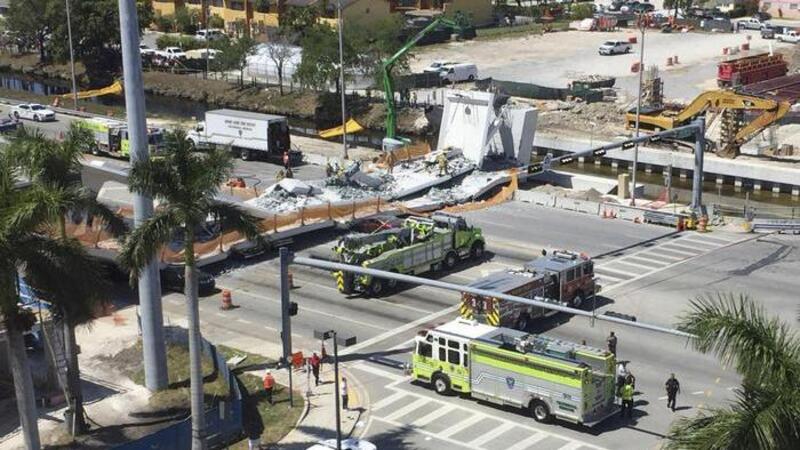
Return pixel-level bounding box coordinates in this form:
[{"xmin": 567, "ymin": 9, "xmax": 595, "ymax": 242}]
[{"xmin": 120, "ymin": 130, "xmax": 261, "ymax": 450}]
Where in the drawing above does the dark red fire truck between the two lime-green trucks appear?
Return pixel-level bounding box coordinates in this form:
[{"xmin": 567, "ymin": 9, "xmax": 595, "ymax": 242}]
[{"xmin": 459, "ymin": 251, "xmax": 599, "ymax": 330}]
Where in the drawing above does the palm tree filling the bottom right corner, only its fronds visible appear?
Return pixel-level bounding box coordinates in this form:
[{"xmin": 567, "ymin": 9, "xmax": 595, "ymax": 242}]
[{"xmin": 667, "ymin": 294, "xmax": 800, "ymax": 450}]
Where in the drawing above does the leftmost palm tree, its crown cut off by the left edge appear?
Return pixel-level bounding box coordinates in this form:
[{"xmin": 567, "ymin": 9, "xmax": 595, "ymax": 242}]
[{"xmin": 0, "ymin": 152, "xmax": 111, "ymax": 449}]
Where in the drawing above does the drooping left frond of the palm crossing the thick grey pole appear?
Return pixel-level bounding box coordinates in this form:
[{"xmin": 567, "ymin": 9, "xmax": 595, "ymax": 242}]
[{"xmin": 119, "ymin": 208, "xmax": 184, "ymax": 281}]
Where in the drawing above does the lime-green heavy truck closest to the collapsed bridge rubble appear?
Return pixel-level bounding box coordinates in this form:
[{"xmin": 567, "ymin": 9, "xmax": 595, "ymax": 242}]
[{"xmin": 333, "ymin": 213, "xmax": 485, "ymax": 296}]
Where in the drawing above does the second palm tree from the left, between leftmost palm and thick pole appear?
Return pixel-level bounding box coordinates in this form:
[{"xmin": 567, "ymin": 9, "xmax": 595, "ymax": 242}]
[{"xmin": 6, "ymin": 123, "xmax": 127, "ymax": 434}]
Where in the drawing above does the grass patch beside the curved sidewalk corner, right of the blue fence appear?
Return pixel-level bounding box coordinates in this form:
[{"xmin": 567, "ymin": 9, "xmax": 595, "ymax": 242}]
[{"xmin": 228, "ymin": 373, "xmax": 305, "ymax": 450}]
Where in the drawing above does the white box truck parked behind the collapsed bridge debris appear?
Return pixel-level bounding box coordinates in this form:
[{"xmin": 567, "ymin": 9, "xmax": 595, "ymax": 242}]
[{"xmin": 187, "ymin": 109, "xmax": 303, "ymax": 166}]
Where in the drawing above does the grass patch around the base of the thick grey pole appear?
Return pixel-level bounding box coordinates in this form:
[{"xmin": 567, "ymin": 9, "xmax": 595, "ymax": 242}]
[{"xmin": 120, "ymin": 340, "xmax": 230, "ymax": 410}]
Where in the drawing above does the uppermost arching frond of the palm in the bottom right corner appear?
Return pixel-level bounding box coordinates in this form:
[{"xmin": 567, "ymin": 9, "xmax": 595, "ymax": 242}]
[{"xmin": 678, "ymin": 293, "xmax": 800, "ymax": 383}]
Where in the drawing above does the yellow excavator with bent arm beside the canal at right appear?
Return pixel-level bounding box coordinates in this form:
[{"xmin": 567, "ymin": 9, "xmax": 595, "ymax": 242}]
[{"xmin": 625, "ymin": 89, "xmax": 792, "ymax": 157}]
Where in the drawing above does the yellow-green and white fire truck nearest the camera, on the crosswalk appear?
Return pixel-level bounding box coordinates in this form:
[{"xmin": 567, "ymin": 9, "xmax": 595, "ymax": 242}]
[{"xmin": 411, "ymin": 318, "xmax": 616, "ymax": 426}]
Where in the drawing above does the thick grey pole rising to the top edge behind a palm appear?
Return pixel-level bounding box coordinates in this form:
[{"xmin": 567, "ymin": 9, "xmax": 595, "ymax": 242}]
[{"xmin": 119, "ymin": 0, "xmax": 168, "ymax": 391}]
